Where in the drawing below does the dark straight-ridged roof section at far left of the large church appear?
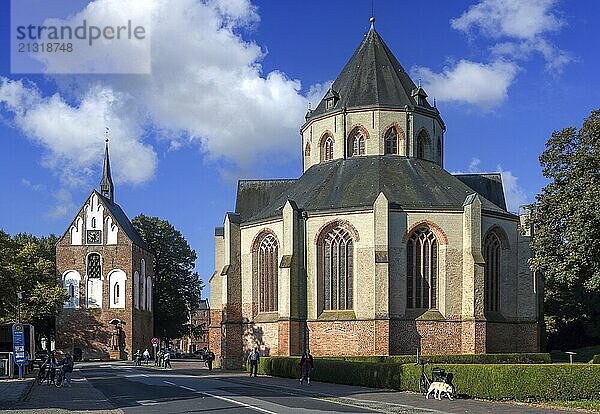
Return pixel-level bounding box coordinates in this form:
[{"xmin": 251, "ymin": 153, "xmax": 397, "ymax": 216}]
[{"xmin": 235, "ymin": 180, "xmax": 296, "ymax": 221}]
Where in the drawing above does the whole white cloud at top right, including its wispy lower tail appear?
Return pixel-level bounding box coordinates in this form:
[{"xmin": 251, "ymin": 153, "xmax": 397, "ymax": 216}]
[{"xmin": 450, "ymin": 0, "xmax": 573, "ymax": 72}]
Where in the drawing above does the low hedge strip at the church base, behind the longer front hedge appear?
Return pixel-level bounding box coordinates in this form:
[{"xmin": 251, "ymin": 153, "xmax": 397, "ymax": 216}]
[{"xmin": 321, "ymin": 353, "xmax": 552, "ymax": 364}]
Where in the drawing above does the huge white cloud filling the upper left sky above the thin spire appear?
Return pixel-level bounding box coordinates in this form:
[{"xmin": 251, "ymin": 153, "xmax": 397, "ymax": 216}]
[{"xmin": 0, "ymin": 0, "xmax": 318, "ymax": 183}]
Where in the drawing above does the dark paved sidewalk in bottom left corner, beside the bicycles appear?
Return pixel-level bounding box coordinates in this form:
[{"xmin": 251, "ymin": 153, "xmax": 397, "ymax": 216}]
[{"xmin": 0, "ymin": 369, "xmax": 122, "ymax": 414}]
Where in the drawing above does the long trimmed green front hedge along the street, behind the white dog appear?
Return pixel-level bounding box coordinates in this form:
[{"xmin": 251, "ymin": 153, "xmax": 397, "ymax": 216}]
[{"xmin": 260, "ymin": 357, "xmax": 600, "ymax": 401}]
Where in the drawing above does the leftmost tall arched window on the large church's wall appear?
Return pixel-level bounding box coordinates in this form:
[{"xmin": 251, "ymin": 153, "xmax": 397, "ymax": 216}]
[{"xmin": 256, "ymin": 233, "xmax": 279, "ymax": 312}]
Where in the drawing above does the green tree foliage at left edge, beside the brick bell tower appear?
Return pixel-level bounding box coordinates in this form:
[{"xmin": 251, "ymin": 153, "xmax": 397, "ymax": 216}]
[{"xmin": 0, "ymin": 230, "xmax": 68, "ymax": 335}]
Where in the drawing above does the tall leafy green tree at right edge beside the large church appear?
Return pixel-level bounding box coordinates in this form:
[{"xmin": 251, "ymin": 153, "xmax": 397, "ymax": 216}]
[{"xmin": 531, "ymin": 110, "xmax": 600, "ymax": 349}]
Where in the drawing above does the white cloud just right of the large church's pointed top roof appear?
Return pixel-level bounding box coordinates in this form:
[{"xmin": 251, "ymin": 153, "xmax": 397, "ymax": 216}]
[{"xmin": 412, "ymin": 60, "xmax": 518, "ymax": 109}]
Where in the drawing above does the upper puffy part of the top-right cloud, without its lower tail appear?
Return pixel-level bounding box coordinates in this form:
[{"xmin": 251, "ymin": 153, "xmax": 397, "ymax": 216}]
[{"xmin": 450, "ymin": 0, "xmax": 565, "ymax": 40}]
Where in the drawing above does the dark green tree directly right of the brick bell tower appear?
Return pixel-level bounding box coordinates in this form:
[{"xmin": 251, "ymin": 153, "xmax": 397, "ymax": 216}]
[{"xmin": 132, "ymin": 215, "xmax": 203, "ymax": 341}]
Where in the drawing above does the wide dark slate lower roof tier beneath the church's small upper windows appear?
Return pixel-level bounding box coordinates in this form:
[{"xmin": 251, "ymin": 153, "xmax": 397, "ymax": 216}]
[{"xmin": 236, "ymin": 155, "xmax": 507, "ymax": 222}]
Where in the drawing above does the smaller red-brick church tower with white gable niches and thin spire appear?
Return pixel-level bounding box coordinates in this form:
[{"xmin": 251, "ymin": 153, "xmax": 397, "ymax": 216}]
[{"xmin": 56, "ymin": 140, "xmax": 154, "ymax": 359}]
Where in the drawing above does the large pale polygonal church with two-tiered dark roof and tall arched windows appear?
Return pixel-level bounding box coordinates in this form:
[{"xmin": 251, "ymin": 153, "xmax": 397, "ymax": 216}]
[{"xmin": 209, "ymin": 25, "xmax": 542, "ymax": 368}]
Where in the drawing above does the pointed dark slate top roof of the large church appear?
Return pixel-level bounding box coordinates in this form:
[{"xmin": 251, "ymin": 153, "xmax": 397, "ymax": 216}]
[{"xmin": 307, "ymin": 27, "xmax": 435, "ymax": 118}]
